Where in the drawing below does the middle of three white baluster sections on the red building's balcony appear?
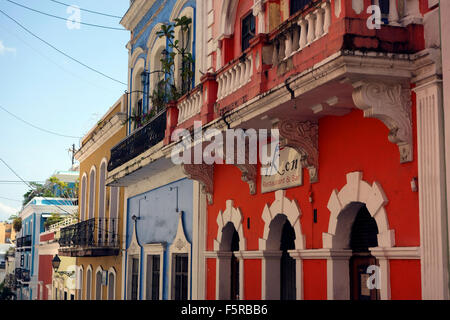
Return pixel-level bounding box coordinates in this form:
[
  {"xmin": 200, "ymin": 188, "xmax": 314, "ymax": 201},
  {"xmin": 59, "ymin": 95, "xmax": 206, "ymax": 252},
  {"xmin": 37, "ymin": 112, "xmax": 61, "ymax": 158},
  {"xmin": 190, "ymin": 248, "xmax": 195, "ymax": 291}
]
[{"xmin": 217, "ymin": 56, "xmax": 253, "ymax": 100}]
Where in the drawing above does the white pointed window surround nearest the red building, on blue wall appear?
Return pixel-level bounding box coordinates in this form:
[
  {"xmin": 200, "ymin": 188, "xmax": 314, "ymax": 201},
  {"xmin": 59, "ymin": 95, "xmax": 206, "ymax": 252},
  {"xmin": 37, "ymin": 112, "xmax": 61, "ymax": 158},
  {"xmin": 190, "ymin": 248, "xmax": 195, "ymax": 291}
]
[{"xmin": 168, "ymin": 211, "xmax": 192, "ymax": 300}]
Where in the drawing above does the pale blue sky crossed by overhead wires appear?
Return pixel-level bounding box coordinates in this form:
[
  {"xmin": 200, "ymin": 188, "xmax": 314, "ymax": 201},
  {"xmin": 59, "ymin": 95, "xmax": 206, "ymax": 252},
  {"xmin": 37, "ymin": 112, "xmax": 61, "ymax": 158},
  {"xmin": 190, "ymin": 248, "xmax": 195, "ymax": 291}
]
[{"xmin": 0, "ymin": 0, "xmax": 130, "ymax": 221}]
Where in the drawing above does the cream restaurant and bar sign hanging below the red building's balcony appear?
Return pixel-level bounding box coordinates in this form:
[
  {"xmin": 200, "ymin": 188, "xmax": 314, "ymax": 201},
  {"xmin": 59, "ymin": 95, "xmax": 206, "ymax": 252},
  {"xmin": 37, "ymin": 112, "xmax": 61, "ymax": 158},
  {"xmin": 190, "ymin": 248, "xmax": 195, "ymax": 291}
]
[{"xmin": 261, "ymin": 148, "xmax": 303, "ymax": 193}]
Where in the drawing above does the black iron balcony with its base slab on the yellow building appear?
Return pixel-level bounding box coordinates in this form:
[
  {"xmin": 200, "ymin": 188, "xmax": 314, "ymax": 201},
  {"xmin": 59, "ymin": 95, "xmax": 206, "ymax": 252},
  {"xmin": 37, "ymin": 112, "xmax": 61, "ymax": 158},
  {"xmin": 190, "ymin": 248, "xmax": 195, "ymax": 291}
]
[{"xmin": 58, "ymin": 218, "xmax": 119, "ymax": 257}]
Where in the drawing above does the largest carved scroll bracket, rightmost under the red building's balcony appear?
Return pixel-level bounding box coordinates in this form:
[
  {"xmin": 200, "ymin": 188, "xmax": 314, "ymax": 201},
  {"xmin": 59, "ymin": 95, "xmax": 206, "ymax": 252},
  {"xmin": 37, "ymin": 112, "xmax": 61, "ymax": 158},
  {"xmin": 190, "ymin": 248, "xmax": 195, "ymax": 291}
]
[{"xmin": 353, "ymin": 81, "xmax": 413, "ymax": 163}]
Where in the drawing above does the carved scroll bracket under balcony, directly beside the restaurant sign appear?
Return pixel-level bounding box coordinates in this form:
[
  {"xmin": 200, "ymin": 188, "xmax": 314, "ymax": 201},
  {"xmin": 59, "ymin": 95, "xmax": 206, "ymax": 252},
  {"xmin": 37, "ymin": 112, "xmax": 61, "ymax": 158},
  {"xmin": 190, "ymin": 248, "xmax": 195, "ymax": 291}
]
[{"xmin": 278, "ymin": 119, "xmax": 319, "ymax": 183}]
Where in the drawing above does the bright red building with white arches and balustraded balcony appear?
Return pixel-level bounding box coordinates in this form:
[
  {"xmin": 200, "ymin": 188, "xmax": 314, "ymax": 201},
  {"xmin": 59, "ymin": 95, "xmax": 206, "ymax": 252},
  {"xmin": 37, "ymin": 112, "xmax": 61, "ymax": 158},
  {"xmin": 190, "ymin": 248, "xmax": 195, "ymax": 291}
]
[{"xmin": 172, "ymin": 0, "xmax": 442, "ymax": 299}]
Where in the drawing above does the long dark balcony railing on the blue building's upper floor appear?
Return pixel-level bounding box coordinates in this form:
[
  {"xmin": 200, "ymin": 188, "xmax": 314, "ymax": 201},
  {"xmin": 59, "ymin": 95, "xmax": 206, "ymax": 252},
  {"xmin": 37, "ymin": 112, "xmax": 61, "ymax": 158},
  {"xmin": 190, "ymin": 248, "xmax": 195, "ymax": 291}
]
[{"xmin": 108, "ymin": 110, "xmax": 166, "ymax": 171}]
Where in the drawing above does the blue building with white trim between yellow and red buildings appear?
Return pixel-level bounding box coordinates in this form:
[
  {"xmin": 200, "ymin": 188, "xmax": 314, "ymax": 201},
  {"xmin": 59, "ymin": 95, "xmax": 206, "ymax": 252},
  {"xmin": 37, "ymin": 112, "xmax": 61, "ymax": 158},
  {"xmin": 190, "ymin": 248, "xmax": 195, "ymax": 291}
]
[{"xmin": 107, "ymin": 0, "xmax": 206, "ymax": 300}]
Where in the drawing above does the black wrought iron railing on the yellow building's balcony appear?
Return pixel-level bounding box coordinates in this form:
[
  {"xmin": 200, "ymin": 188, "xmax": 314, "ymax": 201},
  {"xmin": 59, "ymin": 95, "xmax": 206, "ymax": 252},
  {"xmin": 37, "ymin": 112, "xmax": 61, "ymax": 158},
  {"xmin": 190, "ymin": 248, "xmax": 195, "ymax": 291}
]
[{"xmin": 59, "ymin": 218, "xmax": 119, "ymax": 248}]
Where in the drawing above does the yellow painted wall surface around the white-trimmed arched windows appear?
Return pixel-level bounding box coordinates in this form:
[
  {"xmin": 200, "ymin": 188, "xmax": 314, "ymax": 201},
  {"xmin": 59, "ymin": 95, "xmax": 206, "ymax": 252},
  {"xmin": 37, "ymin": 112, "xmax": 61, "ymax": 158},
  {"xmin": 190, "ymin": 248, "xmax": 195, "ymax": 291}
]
[{"xmin": 77, "ymin": 98, "xmax": 126, "ymax": 300}]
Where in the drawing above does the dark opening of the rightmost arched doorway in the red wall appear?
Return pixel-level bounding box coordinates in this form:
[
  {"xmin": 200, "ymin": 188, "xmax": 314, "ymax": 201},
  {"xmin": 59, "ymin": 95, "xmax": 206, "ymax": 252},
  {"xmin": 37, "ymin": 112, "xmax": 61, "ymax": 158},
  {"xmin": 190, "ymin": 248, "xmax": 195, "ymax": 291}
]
[{"xmin": 349, "ymin": 205, "xmax": 380, "ymax": 300}]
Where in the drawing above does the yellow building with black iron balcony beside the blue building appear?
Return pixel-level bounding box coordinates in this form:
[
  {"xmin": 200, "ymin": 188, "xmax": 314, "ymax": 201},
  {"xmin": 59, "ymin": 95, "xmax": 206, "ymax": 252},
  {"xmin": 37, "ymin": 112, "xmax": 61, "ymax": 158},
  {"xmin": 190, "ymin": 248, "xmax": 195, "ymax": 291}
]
[{"xmin": 59, "ymin": 95, "xmax": 127, "ymax": 300}]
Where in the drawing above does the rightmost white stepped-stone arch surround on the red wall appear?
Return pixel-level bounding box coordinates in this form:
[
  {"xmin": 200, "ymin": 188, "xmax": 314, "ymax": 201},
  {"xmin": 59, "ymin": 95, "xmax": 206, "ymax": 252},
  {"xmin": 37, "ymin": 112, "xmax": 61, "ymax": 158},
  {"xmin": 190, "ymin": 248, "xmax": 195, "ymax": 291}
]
[{"xmin": 322, "ymin": 172, "xmax": 395, "ymax": 249}]
